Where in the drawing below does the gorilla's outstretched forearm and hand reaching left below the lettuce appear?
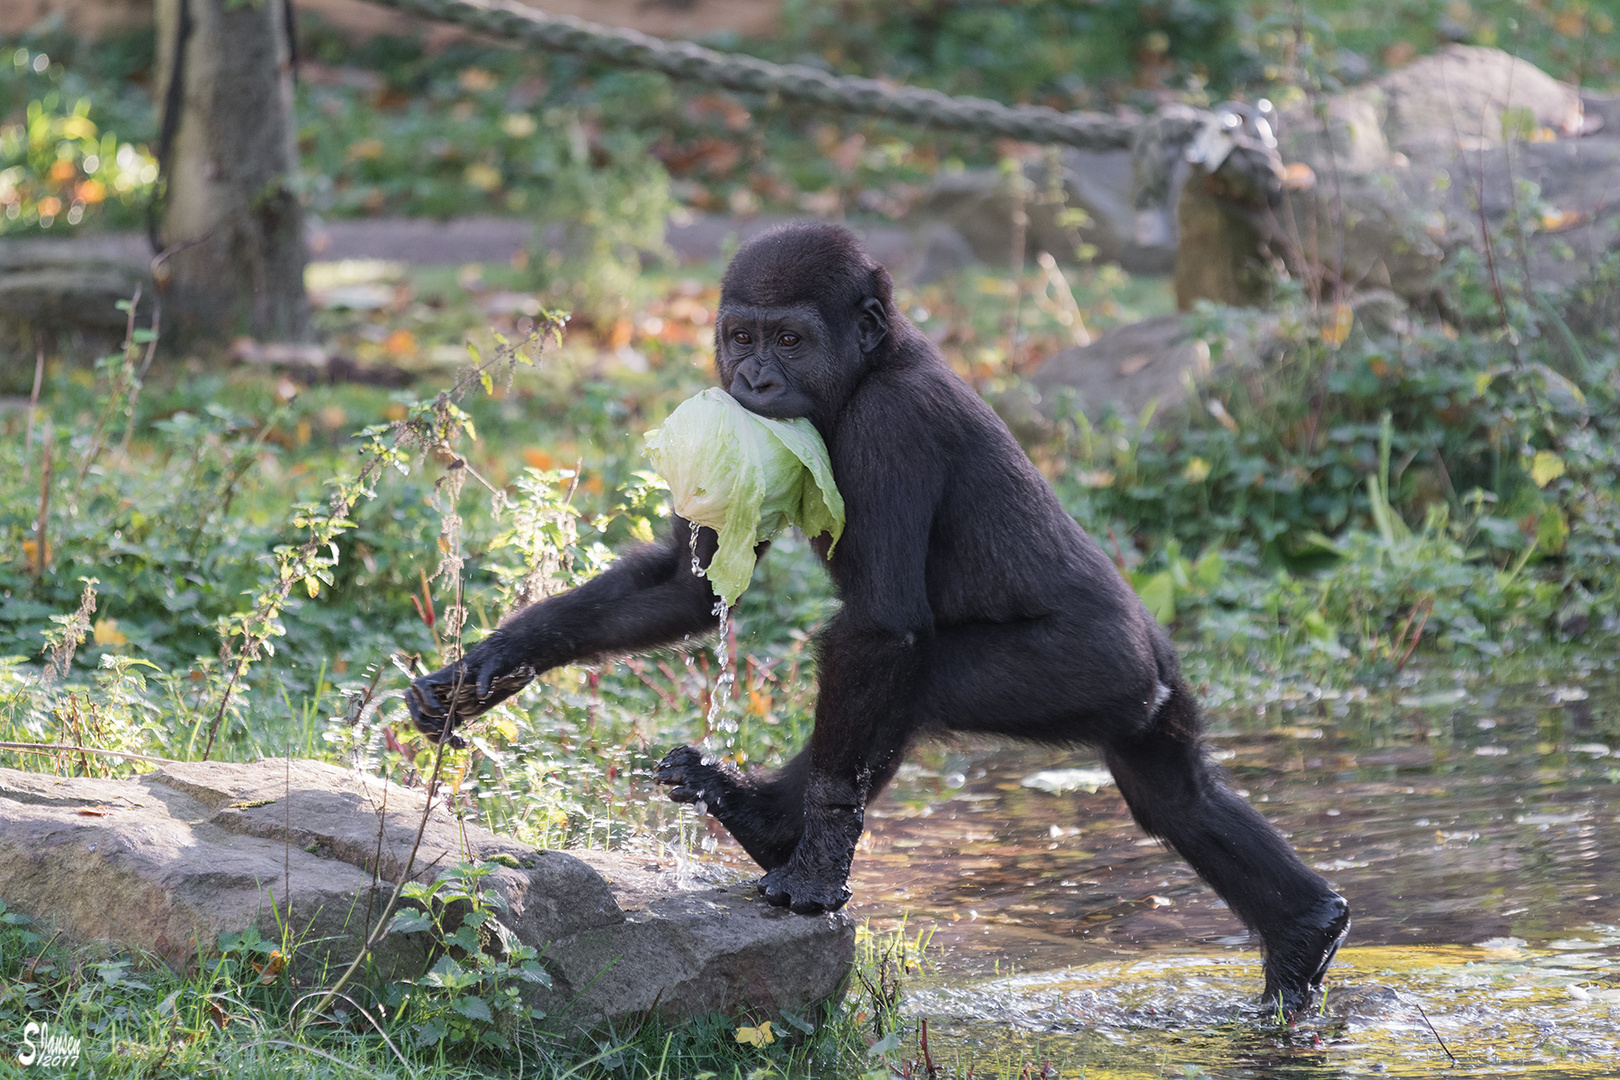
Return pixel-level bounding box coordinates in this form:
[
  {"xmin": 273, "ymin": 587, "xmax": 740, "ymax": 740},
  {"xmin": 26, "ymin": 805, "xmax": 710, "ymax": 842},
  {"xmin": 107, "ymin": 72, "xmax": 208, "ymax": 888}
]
[{"xmin": 405, "ymin": 517, "xmax": 718, "ymax": 745}]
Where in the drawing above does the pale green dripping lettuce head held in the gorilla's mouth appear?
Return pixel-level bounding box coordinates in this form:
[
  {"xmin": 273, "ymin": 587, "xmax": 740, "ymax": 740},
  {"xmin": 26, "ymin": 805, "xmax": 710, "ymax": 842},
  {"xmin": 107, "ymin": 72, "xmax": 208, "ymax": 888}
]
[{"xmin": 646, "ymin": 387, "xmax": 844, "ymax": 604}]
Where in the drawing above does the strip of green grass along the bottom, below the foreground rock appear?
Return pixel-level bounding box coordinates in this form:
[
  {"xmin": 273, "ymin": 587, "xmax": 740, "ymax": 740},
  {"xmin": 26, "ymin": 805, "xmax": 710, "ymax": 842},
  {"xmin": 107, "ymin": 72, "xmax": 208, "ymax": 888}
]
[{"xmin": 0, "ymin": 904, "xmax": 920, "ymax": 1080}]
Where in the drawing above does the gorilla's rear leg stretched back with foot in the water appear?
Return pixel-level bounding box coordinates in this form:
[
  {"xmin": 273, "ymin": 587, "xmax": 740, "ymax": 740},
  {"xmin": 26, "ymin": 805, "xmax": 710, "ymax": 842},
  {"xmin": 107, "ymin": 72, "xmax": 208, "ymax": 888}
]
[{"xmin": 1103, "ymin": 678, "xmax": 1349, "ymax": 1014}]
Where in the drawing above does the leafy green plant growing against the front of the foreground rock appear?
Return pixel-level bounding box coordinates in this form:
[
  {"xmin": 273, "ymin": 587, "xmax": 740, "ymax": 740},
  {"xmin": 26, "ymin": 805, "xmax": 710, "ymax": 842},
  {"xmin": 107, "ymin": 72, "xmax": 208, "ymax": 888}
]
[{"xmin": 387, "ymin": 863, "xmax": 551, "ymax": 1049}]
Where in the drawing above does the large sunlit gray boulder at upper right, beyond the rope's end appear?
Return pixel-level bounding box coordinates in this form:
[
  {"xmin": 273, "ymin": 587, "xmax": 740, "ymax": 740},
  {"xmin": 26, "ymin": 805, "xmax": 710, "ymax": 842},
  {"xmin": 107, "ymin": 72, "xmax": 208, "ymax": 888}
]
[{"xmin": 1278, "ymin": 45, "xmax": 1620, "ymax": 306}]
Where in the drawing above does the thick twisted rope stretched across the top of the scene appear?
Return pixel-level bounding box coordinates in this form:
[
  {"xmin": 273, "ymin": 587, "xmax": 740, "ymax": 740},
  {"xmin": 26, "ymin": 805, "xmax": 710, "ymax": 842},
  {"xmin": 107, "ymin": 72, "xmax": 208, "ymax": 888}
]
[{"xmin": 371, "ymin": 0, "xmax": 1139, "ymax": 151}]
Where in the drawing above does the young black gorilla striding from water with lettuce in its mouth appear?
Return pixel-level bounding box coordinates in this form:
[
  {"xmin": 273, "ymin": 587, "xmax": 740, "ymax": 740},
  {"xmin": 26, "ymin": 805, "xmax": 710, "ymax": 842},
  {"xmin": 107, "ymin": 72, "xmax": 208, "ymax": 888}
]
[{"xmin": 408, "ymin": 223, "xmax": 1349, "ymax": 1012}]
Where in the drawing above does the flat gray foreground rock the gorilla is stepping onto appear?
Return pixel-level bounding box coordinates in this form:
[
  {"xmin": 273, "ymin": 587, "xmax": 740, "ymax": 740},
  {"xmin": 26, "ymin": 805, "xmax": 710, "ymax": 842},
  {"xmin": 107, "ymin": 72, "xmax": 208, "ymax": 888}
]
[{"xmin": 0, "ymin": 759, "xmax": 854, "ymax": 1025}]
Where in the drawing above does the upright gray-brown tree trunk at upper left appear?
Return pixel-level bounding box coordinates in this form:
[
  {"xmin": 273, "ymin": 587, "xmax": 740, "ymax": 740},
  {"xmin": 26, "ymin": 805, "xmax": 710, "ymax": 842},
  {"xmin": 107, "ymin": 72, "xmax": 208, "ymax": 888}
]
[{"xmin": 152, "ymin": 0, "xmax": 311, "ymax": 340}]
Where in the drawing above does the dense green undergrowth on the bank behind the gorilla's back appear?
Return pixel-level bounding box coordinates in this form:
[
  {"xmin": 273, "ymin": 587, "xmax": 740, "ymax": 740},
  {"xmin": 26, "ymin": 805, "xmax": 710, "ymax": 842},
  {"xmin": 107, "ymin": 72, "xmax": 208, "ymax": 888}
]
[{"xmin": 1051, "ymin": 268, "xmax": 1620, "ymax": 678}]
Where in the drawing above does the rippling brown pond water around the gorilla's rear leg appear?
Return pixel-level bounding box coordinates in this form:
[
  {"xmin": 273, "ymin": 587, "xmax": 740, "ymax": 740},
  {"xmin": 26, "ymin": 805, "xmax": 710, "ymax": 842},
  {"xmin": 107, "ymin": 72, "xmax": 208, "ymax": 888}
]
[{"xmin": 693, "ymin": 682, "xmax": 1620, "ymax": 1080}]
